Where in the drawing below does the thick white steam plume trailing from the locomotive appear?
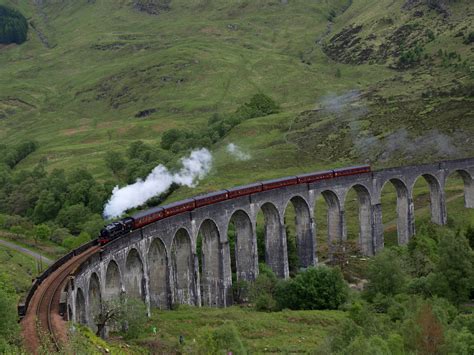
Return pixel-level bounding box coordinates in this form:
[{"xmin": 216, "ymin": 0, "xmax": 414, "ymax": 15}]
[{"xmin": 104, "ymin": 148, "xmax": 212, "ymax": 218}]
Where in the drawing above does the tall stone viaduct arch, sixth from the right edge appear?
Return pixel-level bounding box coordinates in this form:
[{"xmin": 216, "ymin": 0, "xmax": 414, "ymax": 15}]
[{"xmin": 285, "ymin": 196, "xmax": 316, "ymax": 268}]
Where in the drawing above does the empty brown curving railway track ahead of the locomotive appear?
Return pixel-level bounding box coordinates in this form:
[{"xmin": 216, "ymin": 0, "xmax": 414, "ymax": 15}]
[{"xmin": 21, "ymin": 246, "xmax": 100, "ymax": 354}]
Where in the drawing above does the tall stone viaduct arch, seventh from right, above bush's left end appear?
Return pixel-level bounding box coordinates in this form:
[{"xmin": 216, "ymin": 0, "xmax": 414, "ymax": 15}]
[{"xmin": 261, "ymin": 202, "xmax": 289, "ymax": 278}]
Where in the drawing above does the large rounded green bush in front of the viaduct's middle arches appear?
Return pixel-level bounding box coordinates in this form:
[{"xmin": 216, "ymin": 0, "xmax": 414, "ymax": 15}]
[{"xmin": 276, "ymin": 266, "xmax": 348, "ymax": 309}]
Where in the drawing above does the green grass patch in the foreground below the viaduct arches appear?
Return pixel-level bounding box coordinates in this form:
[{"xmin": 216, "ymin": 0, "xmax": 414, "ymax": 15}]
[{"xmin": 130, "ymin": 306, "xmax": 346, "ymax": 354}]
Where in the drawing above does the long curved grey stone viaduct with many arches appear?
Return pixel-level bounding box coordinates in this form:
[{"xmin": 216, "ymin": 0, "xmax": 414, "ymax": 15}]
[{"xmin": 67, "ymin": 159, "xmax": 474, "ymax": 328}]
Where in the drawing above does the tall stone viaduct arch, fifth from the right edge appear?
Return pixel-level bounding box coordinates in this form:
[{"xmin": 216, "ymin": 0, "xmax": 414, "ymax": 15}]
[{"xmin": 321, "ymin": 190, "xmax": 346, "ymax": 259}]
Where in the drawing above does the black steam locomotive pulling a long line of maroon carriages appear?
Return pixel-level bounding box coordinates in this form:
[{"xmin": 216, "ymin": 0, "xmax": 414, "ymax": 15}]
[{"xmin": 98, "ymin": 165, "xmax": 371, "ymax": 245}]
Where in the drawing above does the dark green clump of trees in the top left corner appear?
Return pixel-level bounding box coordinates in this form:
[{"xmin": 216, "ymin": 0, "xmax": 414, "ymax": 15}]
[{"xmin": 0, "ymin": 5, "xmax": 28, "ymax": 44}]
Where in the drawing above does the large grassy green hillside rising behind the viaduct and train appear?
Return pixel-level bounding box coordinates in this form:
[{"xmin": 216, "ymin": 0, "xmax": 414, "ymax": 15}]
[{"xmin": 0, "ymin": 0, "xmax": 474, "ymax": 196}]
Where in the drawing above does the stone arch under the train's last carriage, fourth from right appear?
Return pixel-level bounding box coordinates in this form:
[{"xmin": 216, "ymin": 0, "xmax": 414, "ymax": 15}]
[{"xmin": 345, "ymin": 184, "xmax": 375, "ymax": 256}]
